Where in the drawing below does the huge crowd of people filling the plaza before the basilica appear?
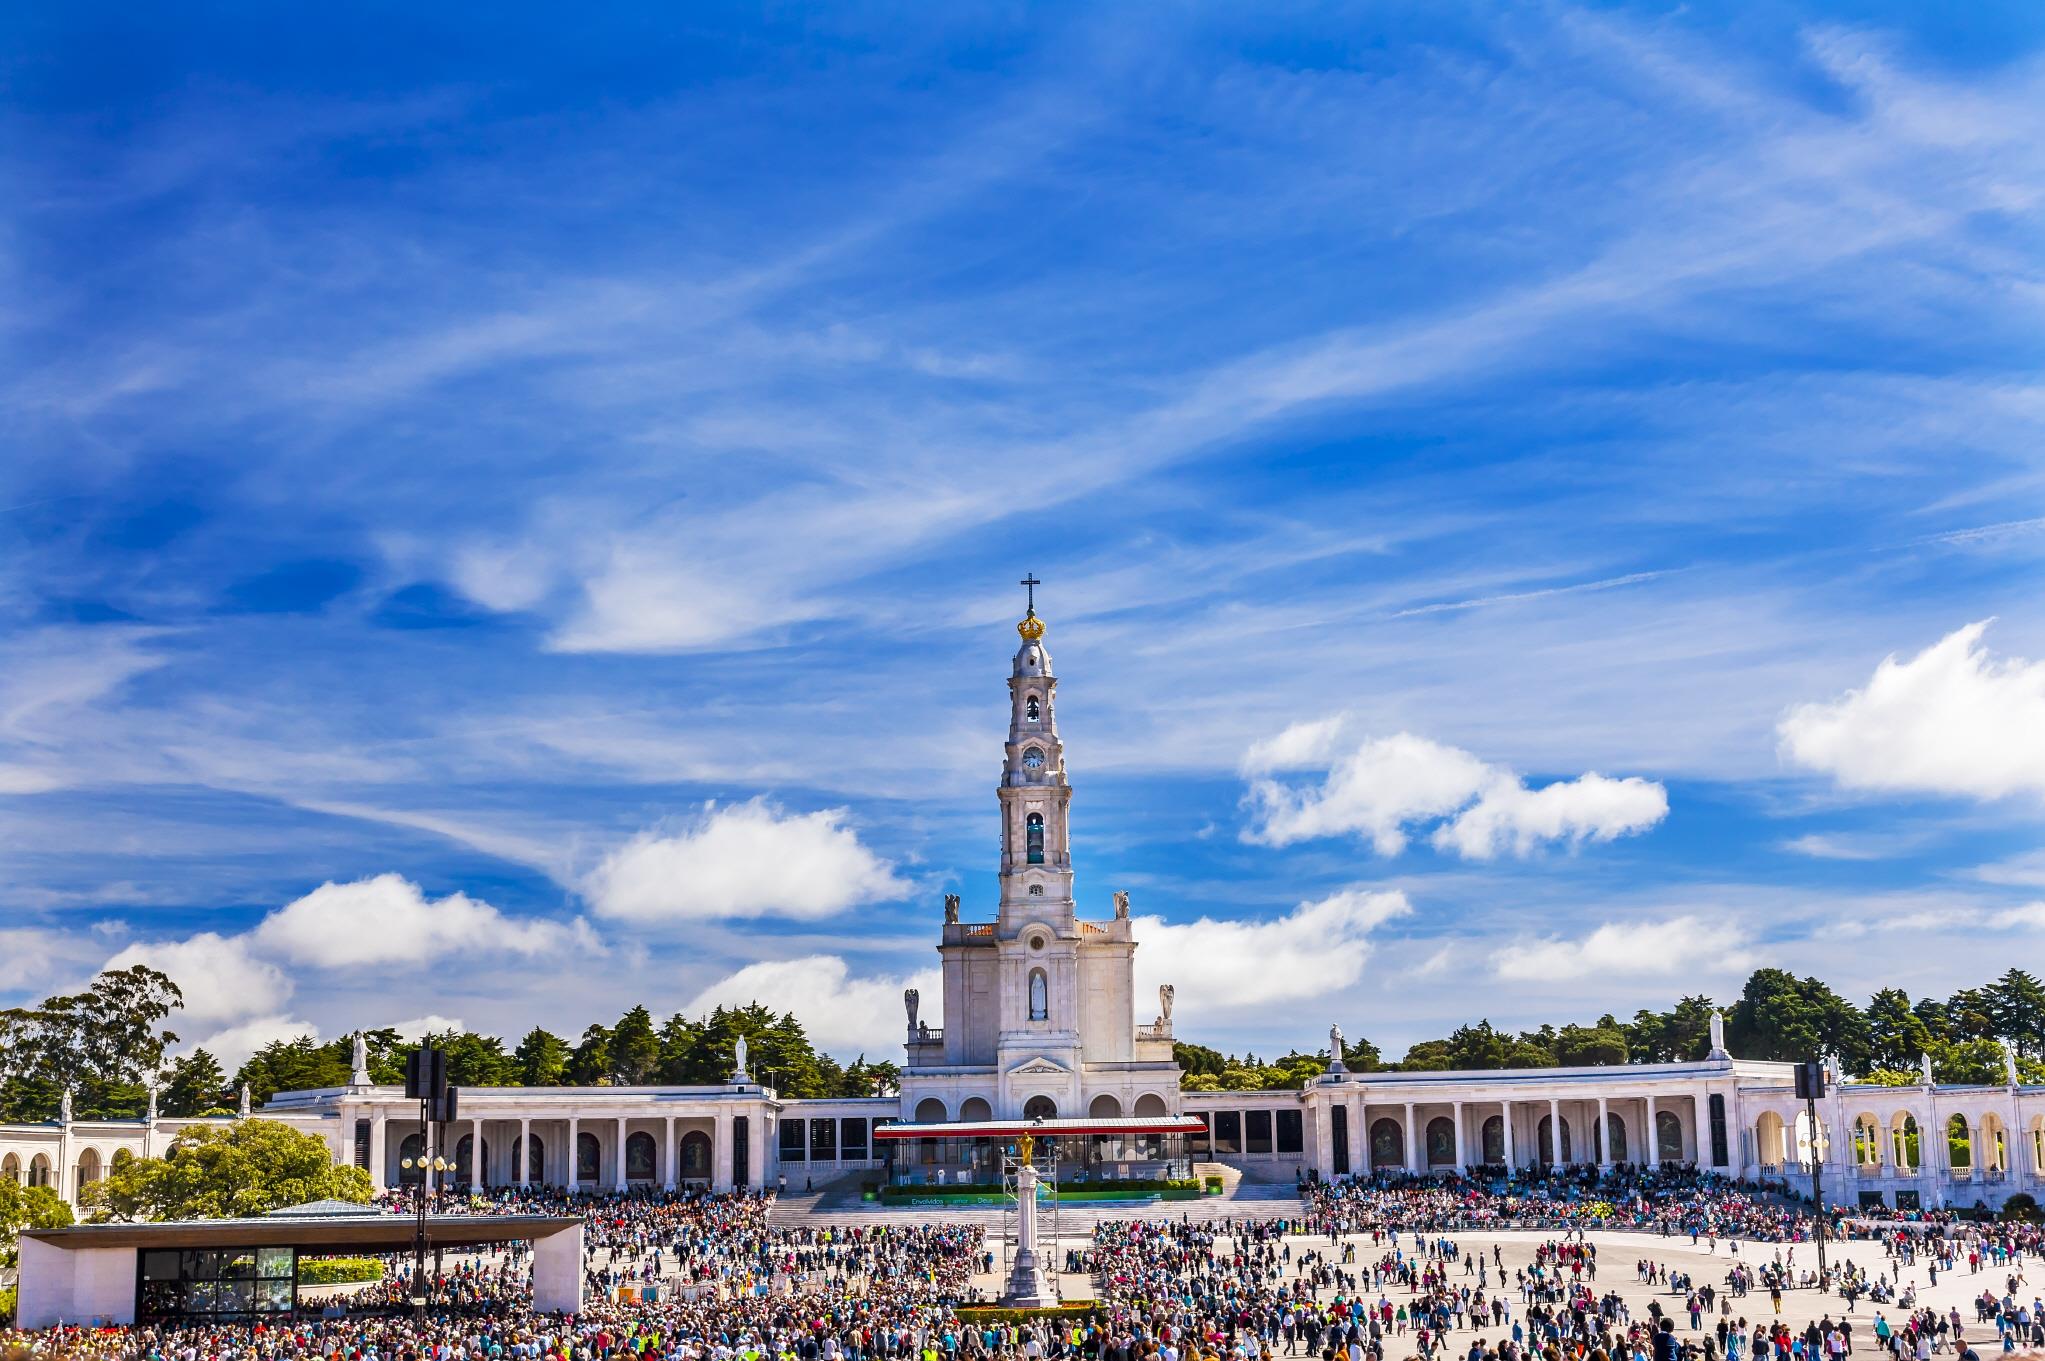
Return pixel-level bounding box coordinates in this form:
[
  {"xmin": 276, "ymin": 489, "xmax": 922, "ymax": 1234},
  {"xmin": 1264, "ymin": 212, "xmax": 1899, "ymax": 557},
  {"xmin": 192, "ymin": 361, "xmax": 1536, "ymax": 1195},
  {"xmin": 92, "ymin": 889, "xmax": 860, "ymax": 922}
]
[{"xmin": 0, "ymin": 1169, "xmax": 2045, "ymax": 1361}]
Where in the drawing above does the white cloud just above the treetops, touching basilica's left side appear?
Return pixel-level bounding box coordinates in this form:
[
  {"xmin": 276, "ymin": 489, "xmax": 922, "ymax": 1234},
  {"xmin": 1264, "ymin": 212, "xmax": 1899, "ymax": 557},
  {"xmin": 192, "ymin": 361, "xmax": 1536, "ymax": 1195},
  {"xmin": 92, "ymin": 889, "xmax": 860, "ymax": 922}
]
[{"xmin": 683, "ymin": 954, "xmax": 945, "ymax": 1059}]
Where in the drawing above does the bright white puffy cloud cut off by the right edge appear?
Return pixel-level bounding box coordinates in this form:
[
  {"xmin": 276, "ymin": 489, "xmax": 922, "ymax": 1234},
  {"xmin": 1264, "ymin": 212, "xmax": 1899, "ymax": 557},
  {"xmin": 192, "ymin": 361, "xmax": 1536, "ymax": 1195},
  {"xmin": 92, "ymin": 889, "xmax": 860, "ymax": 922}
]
[{"xmin": 1777, "ymin": 619, "xmax": 2045, "ymax": 799}]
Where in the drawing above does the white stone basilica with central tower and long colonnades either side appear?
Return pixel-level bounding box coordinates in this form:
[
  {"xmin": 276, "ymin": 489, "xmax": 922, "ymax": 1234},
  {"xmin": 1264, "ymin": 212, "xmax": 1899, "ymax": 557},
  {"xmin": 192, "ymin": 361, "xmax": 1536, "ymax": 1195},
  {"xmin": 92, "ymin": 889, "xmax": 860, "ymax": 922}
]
[{"xmin": 0, "ymin": 580, "xmax": 2045, "ymax": 1208}]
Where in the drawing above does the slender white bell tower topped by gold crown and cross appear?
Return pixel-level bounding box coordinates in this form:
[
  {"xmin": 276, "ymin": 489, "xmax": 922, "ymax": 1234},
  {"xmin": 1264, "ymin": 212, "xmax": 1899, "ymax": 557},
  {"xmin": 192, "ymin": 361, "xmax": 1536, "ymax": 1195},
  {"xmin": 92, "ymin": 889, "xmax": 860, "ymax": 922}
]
[{"xmin": 998, "ymin": 572, "xmax": 1074, "ymax": 934}]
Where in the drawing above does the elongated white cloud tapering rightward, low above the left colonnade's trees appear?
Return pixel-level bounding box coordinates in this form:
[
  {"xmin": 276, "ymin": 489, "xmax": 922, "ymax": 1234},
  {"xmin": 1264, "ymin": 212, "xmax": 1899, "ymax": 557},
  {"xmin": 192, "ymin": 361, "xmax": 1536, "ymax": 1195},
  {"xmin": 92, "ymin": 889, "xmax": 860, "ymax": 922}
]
[{"xmin": 249, "ymin": 875, "xmax": 593, "ymax": 969}]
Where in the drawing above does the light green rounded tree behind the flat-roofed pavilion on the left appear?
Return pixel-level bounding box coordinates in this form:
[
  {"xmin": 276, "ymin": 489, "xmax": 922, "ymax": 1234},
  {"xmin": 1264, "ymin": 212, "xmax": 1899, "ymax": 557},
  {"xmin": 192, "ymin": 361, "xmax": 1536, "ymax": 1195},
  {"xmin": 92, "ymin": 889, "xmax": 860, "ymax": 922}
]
[{"xmin": 80, "ymin": 1120, "xmax": 370, "ymax": 1220}]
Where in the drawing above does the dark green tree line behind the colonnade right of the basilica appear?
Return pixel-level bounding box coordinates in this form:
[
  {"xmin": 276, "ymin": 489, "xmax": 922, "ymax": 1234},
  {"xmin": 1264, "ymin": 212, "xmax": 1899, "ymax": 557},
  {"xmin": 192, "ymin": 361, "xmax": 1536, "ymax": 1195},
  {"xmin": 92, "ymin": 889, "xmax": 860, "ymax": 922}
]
[{"xmin": 1174, "ymin": 969, "xmax": 2045, "ymax": 1091}]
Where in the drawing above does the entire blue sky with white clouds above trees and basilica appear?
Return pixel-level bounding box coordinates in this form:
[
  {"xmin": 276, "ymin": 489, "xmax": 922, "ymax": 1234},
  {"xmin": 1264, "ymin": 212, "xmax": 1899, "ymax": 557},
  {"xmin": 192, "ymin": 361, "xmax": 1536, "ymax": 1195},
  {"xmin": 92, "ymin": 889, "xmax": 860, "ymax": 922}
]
[{"xmin": 0, "ymin": 4, "xmax": 2045, "ymax": 1057}]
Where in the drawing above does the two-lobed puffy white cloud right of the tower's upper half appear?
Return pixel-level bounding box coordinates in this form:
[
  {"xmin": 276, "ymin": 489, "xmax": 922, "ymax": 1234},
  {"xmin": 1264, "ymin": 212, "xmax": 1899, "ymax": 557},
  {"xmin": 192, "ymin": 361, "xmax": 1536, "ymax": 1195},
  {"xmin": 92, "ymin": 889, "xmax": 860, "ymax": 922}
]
[{"xmin": 1243, "ymin": 717, "xmax": 1669, "ymax": 860}]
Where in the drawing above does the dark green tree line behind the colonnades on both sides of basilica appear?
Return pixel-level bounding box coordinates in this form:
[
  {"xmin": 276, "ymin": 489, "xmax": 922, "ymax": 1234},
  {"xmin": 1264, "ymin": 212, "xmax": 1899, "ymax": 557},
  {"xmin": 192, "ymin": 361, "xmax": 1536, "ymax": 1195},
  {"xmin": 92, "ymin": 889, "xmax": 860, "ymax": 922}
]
[{"xmin": 0, "ymin": 965, "xmax": 2045, "ymax": 1122}]
